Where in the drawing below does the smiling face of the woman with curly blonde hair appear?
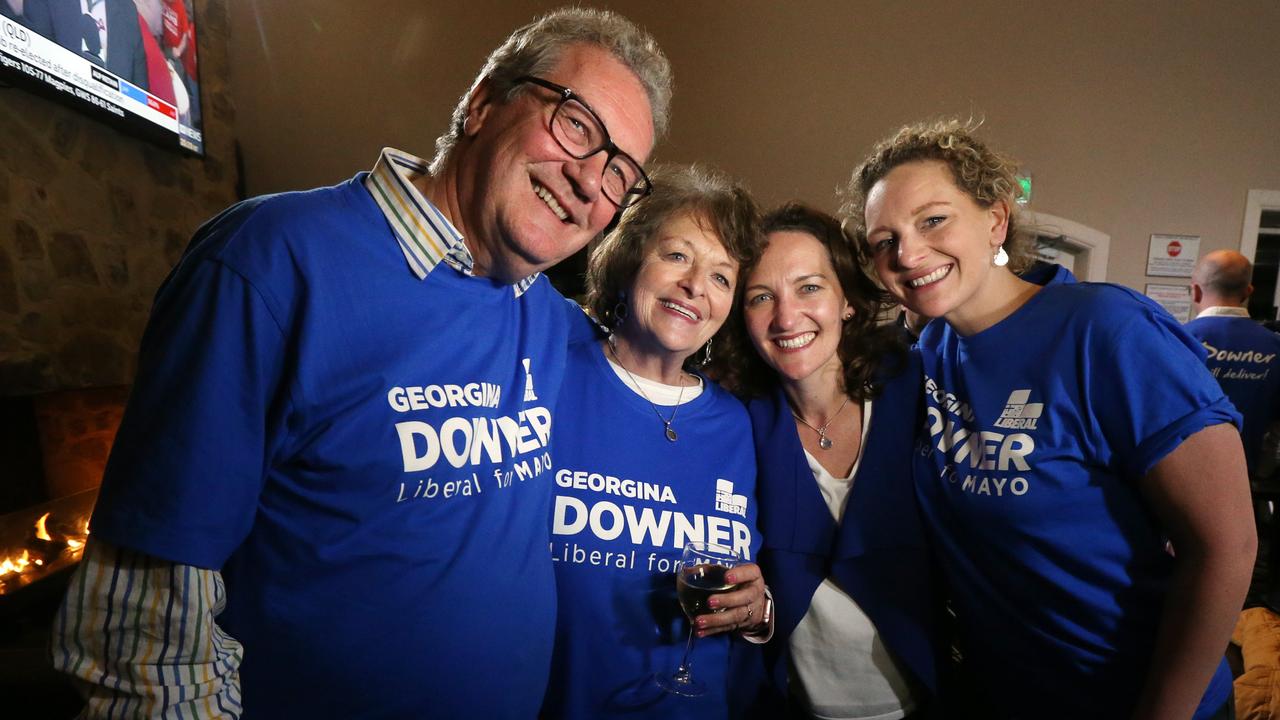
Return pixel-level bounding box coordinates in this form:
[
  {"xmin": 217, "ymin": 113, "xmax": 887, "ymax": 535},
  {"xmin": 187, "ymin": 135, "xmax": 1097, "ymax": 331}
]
[{"xmin": 865, "ymin": 160, "xmax": 1011, "ymax": 332}]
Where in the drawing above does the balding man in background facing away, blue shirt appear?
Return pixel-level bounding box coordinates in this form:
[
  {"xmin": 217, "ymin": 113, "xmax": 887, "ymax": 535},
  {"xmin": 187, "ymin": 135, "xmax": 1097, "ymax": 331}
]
[{"xmin": 1185, "ymin": 250, "xmax": 1280, "ymax": 477}]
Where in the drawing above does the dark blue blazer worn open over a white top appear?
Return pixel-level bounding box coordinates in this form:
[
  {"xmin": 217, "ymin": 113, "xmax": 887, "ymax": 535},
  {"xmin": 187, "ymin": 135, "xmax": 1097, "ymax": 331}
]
[{"xmin": 748, "ymin": 356, "xmax": 937, "ymax": 688}]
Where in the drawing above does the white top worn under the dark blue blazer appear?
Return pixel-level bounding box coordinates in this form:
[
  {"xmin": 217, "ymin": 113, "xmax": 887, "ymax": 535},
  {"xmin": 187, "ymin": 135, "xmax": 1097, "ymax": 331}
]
[{"xmin": 791, "ymin": 401, "xmax": 915, "ymax": 720}]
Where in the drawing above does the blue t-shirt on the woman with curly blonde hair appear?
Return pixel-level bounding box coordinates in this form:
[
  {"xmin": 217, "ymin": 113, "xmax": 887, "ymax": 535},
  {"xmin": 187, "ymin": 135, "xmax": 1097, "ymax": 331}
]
[{"xmin": 916, "ymin": 283, "xmax": 1238, "ymax": 719}]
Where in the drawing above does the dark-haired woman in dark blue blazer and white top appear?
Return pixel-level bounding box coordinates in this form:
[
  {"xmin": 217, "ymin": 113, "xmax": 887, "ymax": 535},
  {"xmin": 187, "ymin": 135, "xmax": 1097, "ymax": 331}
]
[{"xmin": 724, "ymin": 204, "xmax": 938, "ymax": 720}]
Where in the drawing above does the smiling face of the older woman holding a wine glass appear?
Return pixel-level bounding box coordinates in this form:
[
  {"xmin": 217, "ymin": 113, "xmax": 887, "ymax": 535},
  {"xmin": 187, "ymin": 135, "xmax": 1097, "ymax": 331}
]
[{"xmin": 617, "ymin": 213, "xmax": 737, "ymax": 363}]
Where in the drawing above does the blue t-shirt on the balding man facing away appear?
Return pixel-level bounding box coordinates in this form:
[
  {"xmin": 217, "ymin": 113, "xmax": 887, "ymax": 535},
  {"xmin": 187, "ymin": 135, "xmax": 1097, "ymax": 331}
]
[{"xmin": 1183, "ymin": 316, "xmax": 1280, "ymax": 473}]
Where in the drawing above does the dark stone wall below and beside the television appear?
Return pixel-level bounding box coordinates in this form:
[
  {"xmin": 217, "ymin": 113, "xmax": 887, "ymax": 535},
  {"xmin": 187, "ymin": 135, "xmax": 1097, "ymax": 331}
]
[{"xmin": 0, "ymin": 0, "xmax": 238, "ymax": 397}]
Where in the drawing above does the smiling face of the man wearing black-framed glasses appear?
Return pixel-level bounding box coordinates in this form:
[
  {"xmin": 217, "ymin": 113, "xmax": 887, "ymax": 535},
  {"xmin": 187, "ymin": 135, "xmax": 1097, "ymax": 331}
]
[{"xmin": 456, "ymin": 45, "xmax": 654, "ymax": 282}]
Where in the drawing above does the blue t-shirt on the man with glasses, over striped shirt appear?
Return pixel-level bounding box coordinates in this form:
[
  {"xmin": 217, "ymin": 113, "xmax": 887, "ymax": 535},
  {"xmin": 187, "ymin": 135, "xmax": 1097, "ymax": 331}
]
[{"xmin": 92, "ymin": 177, "xmax": 567, "ymax": 717}]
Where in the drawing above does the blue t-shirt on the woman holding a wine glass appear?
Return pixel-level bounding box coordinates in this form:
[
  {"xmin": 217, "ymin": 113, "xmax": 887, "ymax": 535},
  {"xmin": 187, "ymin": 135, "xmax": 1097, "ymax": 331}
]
[{"xmin": 543, "ymin": 341, "xmax": 759, "ymax": 720}]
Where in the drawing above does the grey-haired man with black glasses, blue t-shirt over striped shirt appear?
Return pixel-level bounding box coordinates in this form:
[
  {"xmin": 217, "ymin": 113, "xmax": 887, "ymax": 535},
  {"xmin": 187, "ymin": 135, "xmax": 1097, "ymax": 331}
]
[{"xmin": 52, "ymin": 9, "xmax": 671, "ymax": 719}]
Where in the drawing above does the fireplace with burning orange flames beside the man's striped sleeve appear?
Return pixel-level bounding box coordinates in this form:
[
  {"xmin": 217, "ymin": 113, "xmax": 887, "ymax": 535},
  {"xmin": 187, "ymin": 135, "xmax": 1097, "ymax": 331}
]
[{"xmin": 0, "ymin": 387, "xmax": 128, "ymax": 719}]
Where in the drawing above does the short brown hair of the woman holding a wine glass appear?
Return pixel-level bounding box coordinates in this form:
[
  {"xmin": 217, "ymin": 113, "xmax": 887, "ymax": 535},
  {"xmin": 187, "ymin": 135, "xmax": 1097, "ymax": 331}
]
[{"xmin": 585, "ymin": 165, "xmax": 763, "ymax": 361}]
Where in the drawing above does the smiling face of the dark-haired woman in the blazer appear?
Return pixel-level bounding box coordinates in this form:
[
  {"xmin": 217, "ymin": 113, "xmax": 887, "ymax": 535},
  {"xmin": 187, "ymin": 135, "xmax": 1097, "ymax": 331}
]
[{"xmin": 744, "ymin": 231, "xmax": 852, "ymax": 382}]
